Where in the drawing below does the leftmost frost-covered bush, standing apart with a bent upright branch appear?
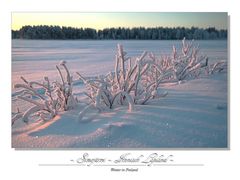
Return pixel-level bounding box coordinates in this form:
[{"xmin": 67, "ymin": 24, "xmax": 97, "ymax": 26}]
[{"xmin": 12, "ymin": 61, "xmax": 76, "ymax": 124}]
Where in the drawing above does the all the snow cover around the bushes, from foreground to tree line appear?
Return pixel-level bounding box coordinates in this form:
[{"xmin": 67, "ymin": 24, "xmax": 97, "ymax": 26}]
[{"xmin": 12, "ymin": 40, "xmax": 228, "ymax": 148}]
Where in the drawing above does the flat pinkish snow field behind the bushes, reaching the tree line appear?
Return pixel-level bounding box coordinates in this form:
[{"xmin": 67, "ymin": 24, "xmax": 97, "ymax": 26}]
[{"xmin": 12, "ymin": 40, "xmax": 227, "ymax": 84}]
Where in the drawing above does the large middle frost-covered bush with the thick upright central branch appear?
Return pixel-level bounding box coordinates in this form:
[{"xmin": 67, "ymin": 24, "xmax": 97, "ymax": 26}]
[{"xmin": 77, "ymin": 45, "xmax": 169, "ymax": 119}]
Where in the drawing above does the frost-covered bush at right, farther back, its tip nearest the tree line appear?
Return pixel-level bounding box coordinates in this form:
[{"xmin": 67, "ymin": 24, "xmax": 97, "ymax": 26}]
[{"xmin": 142, "ymin": 38, "xmax": 208, "ymax": 89}]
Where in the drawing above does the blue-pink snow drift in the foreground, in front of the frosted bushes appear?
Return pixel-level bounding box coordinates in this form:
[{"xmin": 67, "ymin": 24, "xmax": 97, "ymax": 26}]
[{"xmin": 12, "ymin": 74, "xmax": 228, "ymax": 148}]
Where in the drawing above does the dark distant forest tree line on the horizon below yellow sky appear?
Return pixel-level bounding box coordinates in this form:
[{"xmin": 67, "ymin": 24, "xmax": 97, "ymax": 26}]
[{"xmin": 12, "ymin": 25, "xmax": 227, "ymax": 40}]
